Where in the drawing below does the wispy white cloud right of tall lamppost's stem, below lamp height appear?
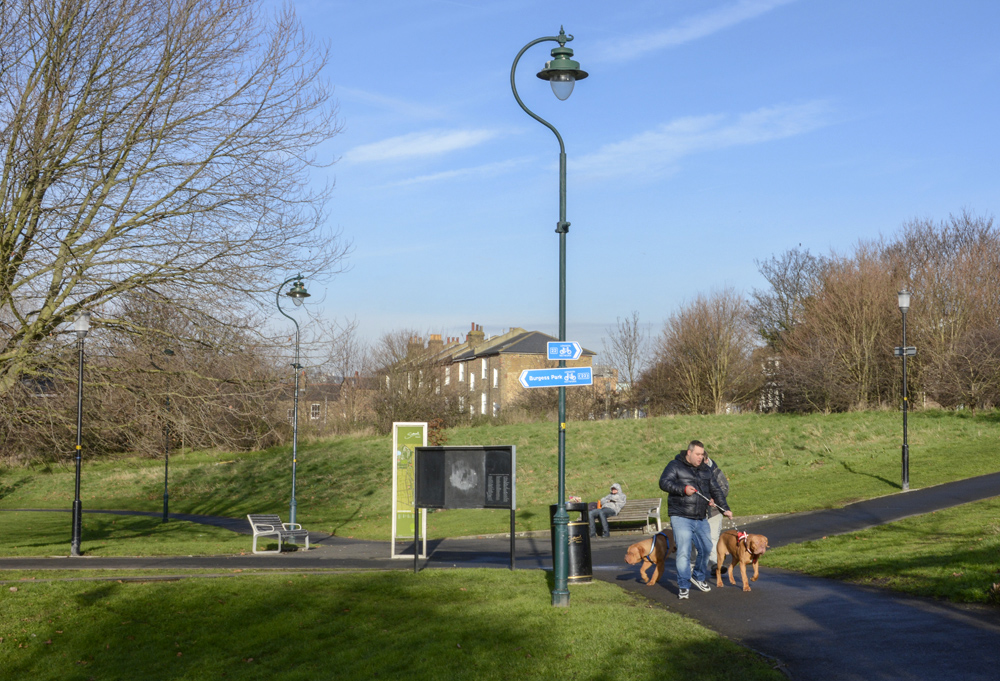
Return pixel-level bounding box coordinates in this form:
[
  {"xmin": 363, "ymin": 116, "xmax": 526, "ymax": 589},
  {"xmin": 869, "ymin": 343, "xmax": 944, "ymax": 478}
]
[{"xmin": 573, "ymin": 101, "xmax": 831, "ymax": 178}]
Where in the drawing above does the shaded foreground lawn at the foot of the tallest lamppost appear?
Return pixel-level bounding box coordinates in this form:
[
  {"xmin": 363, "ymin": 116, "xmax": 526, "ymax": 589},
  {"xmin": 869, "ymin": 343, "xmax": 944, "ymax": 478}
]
[{"xmin": 0, "ymin": 570, "xmax": 785, "ymax": 681}]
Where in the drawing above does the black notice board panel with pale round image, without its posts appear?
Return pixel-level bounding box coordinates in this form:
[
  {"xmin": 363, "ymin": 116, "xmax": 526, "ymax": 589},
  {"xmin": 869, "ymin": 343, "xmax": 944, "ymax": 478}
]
[{"xmin": 414, "ymin": 445, "xmax": 517, "ymax": 510}]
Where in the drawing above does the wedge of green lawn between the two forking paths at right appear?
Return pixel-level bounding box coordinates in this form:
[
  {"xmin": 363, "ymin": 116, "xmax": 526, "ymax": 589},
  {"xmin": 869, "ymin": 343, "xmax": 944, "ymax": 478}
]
[{"xmin": 766, "ymin": 498, "xmax": 1000, "ymax": 605}]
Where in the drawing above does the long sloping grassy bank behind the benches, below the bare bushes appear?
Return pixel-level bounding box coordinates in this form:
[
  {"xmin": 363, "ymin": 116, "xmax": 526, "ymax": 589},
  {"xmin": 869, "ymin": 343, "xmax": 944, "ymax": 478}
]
[{"xmin": 0, "ymin": 411, "xmax": 1000, "ymax": 540}]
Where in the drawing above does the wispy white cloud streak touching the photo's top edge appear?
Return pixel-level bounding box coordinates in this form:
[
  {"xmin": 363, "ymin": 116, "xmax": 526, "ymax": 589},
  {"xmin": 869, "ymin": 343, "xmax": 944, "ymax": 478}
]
[{"xmin": 595, "ymin": 0, "xmax": 794, "ymax": 61}]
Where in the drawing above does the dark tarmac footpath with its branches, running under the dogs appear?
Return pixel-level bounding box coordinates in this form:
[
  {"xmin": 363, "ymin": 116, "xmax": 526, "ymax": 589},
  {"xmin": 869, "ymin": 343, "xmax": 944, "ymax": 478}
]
[{"xmin": 0, "ymin": 473, "xmax": 1000, "ymax": 681}]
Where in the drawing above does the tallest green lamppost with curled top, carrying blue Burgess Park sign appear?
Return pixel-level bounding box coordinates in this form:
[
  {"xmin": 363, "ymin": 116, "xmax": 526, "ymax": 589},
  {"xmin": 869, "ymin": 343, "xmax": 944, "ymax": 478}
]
[{"xmin": 510, "ymin": 27, "xmax": 587, "ymax": 607}]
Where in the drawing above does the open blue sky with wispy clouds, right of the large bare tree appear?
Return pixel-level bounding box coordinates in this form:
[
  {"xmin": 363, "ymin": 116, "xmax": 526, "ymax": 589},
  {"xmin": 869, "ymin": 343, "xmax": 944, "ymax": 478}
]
[{"xmin": 282, "ymin": 0, "xmax": 1000, "ymax": 352}]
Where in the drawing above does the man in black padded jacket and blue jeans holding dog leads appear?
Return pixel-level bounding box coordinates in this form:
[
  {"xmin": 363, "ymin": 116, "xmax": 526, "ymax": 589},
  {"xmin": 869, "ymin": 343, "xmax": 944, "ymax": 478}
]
[{"xmin": 660, "ymin": 440, "xmax": 733, "ymax": 598}]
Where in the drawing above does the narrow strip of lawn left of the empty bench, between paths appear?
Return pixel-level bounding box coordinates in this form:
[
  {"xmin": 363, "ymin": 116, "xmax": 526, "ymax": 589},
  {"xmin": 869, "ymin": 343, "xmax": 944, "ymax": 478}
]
[{"xmin": 0, "ymin": 511, "xmax": 252, "ymax": 557}]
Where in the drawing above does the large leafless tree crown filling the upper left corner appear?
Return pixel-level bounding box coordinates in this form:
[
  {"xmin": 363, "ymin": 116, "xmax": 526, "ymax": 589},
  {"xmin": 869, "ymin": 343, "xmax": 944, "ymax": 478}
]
[{"xmin": 0, "ymin": 0, "xmax": 346, "ymax": 400}]
